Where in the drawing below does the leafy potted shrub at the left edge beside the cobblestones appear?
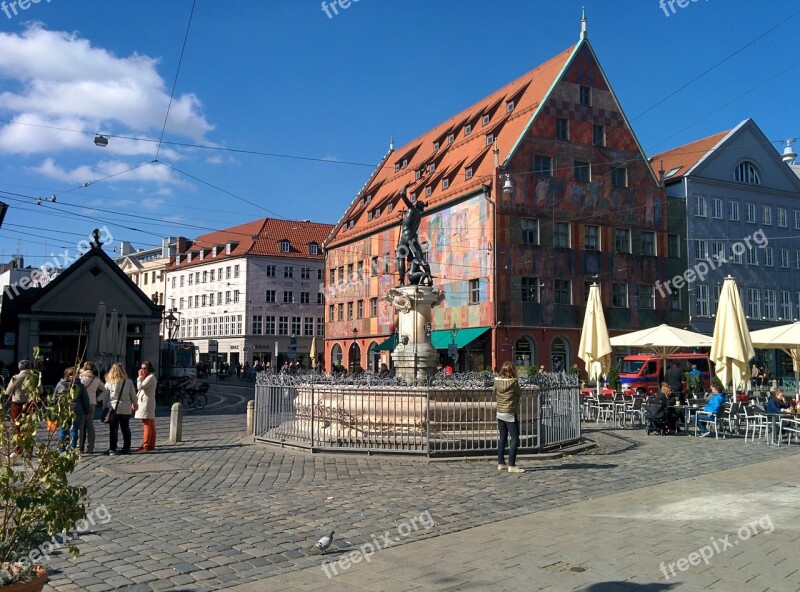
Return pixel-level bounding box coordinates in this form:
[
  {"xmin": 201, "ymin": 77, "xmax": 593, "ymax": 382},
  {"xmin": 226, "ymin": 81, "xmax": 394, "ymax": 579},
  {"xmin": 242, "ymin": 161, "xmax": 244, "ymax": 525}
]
[{"xmin": 0, "ymin": 351, "xmax": 86, "ymax": 592}]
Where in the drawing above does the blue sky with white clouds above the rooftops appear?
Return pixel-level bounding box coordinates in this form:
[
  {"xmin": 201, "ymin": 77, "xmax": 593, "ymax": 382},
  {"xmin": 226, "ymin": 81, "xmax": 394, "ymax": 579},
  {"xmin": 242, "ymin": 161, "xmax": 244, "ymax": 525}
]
[{"xmin": 0, "ymin": 0, "xmax": 800, "ymax": 265}]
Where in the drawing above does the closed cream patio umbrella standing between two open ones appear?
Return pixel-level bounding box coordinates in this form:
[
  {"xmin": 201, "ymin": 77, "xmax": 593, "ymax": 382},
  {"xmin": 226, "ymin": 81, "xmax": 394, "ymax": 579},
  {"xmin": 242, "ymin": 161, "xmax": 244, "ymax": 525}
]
[{"xmin": 709, "ymin": 276, "xmax": 756, "ymax": 392}]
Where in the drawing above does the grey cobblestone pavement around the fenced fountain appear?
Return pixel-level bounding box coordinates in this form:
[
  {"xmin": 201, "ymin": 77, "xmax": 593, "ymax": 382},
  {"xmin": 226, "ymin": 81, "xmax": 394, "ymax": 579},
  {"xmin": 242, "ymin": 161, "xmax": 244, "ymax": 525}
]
[{"xmin": 40, "ymin": 383, "xmax": 800, "ymax": 592}]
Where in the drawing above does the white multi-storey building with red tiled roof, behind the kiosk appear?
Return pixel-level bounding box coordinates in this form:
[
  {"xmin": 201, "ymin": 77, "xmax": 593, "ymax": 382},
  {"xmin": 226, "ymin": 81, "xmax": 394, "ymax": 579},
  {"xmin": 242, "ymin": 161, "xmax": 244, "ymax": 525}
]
[{"xmin": 165, "ymin": 218, "xmax": 333, "ymax": 367}]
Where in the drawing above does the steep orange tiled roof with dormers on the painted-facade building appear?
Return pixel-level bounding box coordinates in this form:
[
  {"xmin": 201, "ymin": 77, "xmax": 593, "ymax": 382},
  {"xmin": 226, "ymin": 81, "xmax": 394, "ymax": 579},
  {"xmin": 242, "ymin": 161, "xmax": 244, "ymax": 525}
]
[{"xmin": 325, "ymin": 46, "xmax": 576, "ymax": 248}]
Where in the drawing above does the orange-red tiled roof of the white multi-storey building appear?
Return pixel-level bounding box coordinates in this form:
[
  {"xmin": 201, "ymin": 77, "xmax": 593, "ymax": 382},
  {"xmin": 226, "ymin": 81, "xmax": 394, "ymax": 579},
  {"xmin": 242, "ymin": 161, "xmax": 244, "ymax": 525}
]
[{"xmin": 168, "ymin": 218, "xmax": 333, "ymax": 270}]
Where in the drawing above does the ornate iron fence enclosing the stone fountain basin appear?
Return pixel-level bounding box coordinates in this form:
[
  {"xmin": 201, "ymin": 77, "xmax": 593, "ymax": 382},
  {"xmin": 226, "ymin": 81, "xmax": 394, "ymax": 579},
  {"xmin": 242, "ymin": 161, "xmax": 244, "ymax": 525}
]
[{"xmin": 254, "ymin": 372, "xmax": 581, "ymax": 456}]
